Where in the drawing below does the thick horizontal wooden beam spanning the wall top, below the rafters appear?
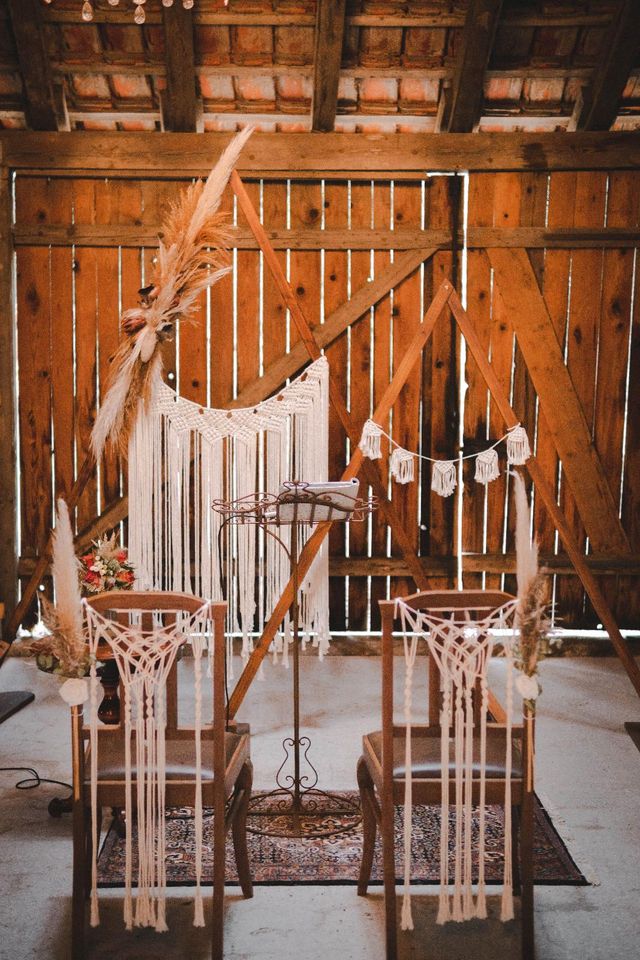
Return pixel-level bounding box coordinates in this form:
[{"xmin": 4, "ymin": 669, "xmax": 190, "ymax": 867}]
[{"xmin": 5, "ymin": 130, "xmax": 640, "ymax": 180}]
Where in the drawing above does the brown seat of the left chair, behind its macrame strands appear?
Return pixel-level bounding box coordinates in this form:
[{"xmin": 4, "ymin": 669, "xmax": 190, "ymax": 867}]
[{"xmin": 85, "ymin": 732, "xmax": 249, "ymax": 784}]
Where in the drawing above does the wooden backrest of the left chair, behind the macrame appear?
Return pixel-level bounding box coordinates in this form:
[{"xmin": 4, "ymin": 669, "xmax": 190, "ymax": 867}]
[{"xmin": 87, "ymin": 590, "xmax": 227, "ymax": 737}]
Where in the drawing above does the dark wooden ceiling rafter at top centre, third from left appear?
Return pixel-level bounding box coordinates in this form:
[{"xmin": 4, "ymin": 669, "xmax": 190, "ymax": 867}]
[{"xmin": 311, "ymin": 0, "xmax": 346, "ymax": 133}]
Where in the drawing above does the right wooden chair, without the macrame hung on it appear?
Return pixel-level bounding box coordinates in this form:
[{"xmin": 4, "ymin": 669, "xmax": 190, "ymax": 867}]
[{"xmin": 357, "ymin": 590, "xmax": 534, "ymax": 960}]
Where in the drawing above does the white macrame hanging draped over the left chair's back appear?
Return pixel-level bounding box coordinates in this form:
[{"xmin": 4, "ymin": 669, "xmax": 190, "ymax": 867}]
[{"xmin": 80, "ymin": 600, "xmax": 212, "ymax": 931}]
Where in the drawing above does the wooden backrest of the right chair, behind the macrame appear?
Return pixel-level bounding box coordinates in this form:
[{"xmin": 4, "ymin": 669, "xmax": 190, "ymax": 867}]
[{"xmin": 379, "ymin": 590, "xmax": 515, "ymax": 726}]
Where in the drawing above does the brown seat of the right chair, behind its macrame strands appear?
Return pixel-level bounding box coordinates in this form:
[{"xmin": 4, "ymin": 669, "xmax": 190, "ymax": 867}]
[{"xmin": 364, "ymin": 727, "xmax": 522, "ymax": 780}]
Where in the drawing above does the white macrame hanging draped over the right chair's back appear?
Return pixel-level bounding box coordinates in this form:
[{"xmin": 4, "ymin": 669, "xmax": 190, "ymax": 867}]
[{"xmin": 396, "ymin": 599, "xmax": 518, "ymax": 930}]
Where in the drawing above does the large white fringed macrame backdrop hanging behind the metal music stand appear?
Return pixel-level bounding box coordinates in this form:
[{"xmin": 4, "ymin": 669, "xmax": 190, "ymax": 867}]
[{"xmin": 129, "ymin": 357, "xmax": 329, "ymax": 675}]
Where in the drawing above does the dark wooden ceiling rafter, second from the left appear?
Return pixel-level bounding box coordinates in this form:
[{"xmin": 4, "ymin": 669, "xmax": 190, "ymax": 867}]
[{"xmin": 162, "ymin": 3, "xmax": 201, "ymax": 133}]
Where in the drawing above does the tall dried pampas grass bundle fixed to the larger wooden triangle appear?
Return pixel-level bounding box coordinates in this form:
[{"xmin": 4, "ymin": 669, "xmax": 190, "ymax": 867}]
[{"xmin": 91, "ymin": 127, "xmax": 253, "ymax": 460}]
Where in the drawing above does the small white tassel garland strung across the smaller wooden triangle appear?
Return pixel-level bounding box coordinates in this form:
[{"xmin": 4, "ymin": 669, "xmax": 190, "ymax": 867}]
[{"xmin": 359, "ymin": 420, "xmax": 531, "ymax": 497}]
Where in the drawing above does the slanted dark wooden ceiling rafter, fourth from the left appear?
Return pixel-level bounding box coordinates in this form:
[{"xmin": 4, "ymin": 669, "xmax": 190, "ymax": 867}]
[{"xmin": 441, "ymin": 0, "xmax": 502, "ymax": 133}]
